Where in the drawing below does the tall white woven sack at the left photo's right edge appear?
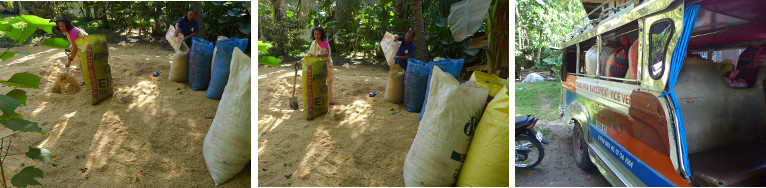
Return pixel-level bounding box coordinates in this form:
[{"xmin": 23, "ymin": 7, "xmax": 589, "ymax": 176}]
[{"xmin": 202, "ymin": 48, "xmax": 250, "ymax": 186}]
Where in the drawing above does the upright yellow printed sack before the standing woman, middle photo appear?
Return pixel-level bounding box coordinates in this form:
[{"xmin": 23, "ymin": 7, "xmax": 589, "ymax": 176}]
[{"xmin": 301, "ymin": 57, "xmax": 329, "ymax": 120}]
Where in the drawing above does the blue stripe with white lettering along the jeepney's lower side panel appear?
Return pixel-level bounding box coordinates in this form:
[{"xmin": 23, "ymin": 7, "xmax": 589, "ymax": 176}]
[{"xmin": 590, "ymin": 124, "xmax": 676, "ymax": 187}]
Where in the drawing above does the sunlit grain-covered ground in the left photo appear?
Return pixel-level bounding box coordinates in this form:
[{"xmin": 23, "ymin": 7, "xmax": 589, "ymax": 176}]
[{"xmin": 0, "ymin": 42, "xmax": 250, "ymax": 187}]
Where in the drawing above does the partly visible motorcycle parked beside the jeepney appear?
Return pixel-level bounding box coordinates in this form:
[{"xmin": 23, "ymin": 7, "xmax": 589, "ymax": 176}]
[{"xmin": 515, "ymin": 115, "xmax": 549, "ymax": 169}]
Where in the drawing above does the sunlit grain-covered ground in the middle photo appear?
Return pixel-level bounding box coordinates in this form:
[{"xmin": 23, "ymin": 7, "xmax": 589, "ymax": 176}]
[{"xmin": 258, "ymin": 57, "xmax": 419, "ymax": 187}]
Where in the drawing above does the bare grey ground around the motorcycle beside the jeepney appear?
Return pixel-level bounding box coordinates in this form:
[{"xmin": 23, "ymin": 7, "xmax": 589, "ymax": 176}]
[{"xmin": 515, "ymin": 120, "xmax": 611, "ymax": 187}]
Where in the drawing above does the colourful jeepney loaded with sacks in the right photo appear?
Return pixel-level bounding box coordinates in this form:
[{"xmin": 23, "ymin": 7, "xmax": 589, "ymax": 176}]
[{"xmin": 559, "ymin": 0, "xmax": 766, "ymax": 186}]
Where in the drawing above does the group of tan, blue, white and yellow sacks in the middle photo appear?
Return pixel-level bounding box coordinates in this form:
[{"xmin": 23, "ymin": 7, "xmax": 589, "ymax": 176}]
[{"xmin": 385, "ymin": 58, "xmax": 510, "ymax": 186}]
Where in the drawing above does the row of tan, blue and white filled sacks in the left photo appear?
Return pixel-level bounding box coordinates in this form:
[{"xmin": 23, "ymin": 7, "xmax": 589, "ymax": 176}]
[{"xmin": 166, "ymin": 27, "xmax": 251, "ymax": 186}]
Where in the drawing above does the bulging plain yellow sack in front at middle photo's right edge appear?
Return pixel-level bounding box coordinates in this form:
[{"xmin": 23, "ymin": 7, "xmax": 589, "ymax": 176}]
[{"xmin": 457, "ymin": 85, "xmax": 510, "ymax": 187}]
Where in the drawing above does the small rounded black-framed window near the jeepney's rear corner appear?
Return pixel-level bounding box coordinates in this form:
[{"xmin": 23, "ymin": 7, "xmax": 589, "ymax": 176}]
[{"xmin": 648, "ymin": 19, "xmax": 674, "ymax": 80}]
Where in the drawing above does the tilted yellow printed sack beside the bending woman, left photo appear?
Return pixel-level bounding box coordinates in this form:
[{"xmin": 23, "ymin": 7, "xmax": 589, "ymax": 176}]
[{"xmin": 75, "ymin": 34, "xmax": 114, "ymax": 105}]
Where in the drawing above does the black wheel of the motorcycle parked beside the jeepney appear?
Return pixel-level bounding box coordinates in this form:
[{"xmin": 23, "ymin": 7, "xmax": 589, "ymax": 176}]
[{"xmin": 515, "ymin": 135, "xmax": 545, "ymax": 170}]
